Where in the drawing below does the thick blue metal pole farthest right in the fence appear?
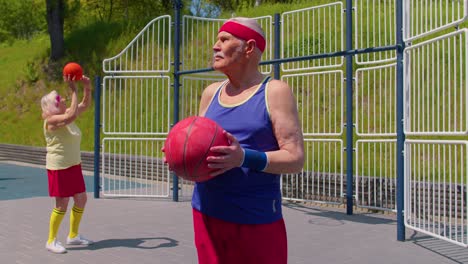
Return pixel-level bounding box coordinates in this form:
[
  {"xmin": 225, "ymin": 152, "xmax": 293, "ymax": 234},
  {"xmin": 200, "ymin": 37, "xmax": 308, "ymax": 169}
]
[{"xmin": 396, "ymin": 0, "xmax": 405, "ymax": 241}]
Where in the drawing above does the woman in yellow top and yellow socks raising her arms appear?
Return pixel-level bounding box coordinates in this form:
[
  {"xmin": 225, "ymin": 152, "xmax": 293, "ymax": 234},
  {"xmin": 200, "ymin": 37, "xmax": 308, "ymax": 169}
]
[{"xmin": 41, "ymin": 76, "xmax": 93, "ymax": 253}]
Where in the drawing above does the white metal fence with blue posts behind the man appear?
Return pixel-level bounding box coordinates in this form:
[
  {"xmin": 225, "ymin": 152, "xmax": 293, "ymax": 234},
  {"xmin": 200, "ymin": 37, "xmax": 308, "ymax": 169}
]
[{"xmin": 97, "ymin": 0, "xmax": 468, "ymax": 246}]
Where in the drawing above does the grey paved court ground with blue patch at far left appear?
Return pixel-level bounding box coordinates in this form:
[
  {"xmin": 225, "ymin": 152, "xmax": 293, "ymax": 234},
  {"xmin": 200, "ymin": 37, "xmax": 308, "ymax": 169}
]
[{"xmin": 0, "ymin": 163, "xmax": 468, "ymax": 264}]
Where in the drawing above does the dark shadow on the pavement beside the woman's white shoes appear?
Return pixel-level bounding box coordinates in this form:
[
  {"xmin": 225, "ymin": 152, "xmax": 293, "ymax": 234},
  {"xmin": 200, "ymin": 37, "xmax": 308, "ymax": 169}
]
[{"xmin": 67, "ymin": 237, "xmax": 179, "ymax": 251}]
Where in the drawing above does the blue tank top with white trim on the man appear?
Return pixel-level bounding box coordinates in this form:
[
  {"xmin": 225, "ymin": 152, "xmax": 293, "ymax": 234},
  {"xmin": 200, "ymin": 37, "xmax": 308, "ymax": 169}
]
[{"xmin": 192, "ymin": 77, "xmax": 282, "ymax": 224}]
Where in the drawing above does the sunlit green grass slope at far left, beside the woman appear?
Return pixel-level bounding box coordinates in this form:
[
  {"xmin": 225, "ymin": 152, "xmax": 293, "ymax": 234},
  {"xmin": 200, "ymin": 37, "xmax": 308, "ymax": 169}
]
[{"xmin": 0, "ymin": 35, "xmax": 49, "ymax": 146}]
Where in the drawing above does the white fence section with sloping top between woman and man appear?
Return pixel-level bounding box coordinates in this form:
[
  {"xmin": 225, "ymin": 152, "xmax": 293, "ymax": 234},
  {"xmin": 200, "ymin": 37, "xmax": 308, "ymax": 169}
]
[{"xmin": 100, "ymin": 16, "xmax": 173, "ymax": 198}]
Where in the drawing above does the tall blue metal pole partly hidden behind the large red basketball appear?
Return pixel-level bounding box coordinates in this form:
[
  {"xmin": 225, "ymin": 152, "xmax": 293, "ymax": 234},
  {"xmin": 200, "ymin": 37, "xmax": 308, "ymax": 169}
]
[{"xmin": 172, "ymin": 0, "xmax": 182, "ymax": 202}]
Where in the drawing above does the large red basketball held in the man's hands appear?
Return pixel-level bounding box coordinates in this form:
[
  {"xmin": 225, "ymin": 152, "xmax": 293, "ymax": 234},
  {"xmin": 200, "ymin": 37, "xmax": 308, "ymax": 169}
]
[{"xmin": 164, "ymin": 116, "xmax": 229, "ymax": 182}]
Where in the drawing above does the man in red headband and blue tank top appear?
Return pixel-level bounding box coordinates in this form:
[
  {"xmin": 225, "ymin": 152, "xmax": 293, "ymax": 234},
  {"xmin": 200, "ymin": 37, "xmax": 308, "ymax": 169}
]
[{"xmin": 192, "ymin": 17, "xmax": 304, "ymax": 264}]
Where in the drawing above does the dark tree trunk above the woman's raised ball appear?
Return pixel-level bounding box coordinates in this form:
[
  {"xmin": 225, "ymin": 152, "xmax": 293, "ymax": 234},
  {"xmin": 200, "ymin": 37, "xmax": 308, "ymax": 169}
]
[{"xmin": 46, "ymin": 0, "xmax": 65, "ymax": 61}]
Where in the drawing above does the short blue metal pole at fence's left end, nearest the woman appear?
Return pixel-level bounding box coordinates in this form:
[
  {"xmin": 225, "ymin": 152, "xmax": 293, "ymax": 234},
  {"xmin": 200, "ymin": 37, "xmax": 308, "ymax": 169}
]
[{"xmin": 94, "ymin": 76, "xmax": 101, "ymax": 198}]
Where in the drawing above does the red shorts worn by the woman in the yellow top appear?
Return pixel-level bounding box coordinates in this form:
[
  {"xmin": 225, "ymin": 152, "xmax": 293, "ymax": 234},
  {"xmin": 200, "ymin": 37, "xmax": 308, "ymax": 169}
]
[{"xmin": 47, "ymin": 164, "xmax": 86, "ymax": 197}]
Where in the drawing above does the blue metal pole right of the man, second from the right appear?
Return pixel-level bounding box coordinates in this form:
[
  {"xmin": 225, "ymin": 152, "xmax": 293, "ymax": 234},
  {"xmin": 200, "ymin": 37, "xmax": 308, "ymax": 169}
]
[{"xmin": 346, "ymin": 0, "xmax": 354, "ymax": 215}]
